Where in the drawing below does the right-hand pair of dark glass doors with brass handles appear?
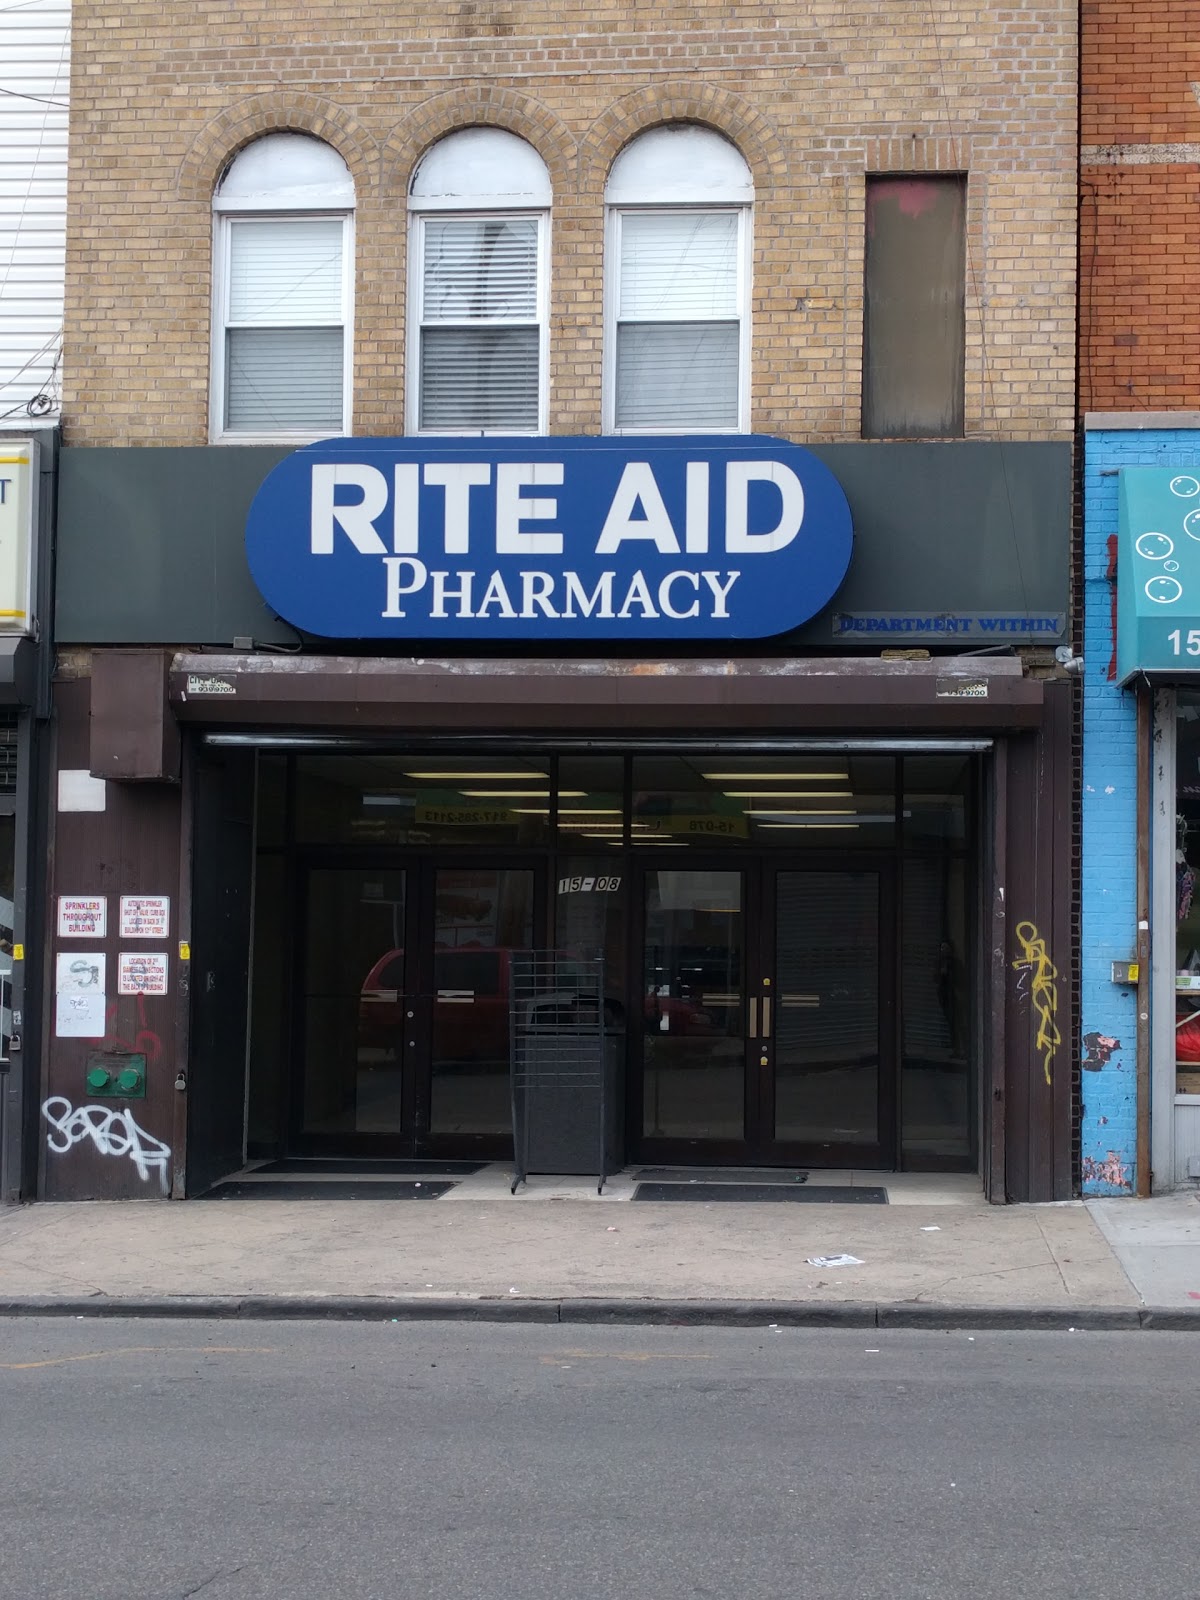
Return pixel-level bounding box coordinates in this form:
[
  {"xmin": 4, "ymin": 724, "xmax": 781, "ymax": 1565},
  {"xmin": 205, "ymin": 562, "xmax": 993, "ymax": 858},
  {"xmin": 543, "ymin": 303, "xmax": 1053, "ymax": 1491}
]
[{"xmin": 640, "ymin": 859, "xmax": 896, "ymax": 1166}]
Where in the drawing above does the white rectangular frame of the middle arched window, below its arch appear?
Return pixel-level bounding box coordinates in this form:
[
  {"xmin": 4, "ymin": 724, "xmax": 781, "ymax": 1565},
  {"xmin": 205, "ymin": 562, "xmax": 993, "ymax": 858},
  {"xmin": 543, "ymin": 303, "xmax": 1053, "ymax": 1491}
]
[{"xmin": 405, "ymin": 212, "xmax": 550, "ymax": 438}]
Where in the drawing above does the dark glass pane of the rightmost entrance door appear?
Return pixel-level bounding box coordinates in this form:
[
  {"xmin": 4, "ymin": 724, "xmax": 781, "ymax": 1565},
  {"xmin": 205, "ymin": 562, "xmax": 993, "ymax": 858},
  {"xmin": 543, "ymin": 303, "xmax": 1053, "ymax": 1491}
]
[{"xmin": 774, "ymin": 870, "xmax": 880, "ymax": 1146}]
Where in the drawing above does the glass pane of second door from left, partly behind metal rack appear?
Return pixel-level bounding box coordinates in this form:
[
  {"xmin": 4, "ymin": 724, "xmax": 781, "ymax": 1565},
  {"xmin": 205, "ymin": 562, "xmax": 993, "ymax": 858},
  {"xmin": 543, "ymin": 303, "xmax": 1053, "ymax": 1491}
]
[{"xmin": 429, "ymin": 867, "xmax": 534, "ymax": 1138}]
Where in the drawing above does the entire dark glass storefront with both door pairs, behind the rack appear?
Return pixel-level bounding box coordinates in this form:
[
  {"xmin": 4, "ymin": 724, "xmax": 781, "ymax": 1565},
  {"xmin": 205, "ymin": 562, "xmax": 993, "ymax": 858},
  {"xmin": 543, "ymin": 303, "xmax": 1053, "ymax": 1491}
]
[{"xmin": 248, "ymin": 750, "xmax": 978, "ymax": 1170}]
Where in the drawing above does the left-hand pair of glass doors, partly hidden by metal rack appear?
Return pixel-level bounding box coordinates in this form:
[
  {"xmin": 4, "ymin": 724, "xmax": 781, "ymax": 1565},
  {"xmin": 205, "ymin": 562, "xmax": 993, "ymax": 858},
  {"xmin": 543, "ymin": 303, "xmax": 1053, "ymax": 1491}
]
[{"xmin": 299, "ymin": 861, "xmax": 538, "ymax": 1155}]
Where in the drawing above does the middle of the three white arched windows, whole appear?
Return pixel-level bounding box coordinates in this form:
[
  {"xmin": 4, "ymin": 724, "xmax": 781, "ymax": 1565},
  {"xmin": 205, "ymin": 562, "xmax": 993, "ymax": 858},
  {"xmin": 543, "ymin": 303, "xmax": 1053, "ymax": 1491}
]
[{"xmin": 408, "ymin": 128, "xmax": 550, "ymax": 434}]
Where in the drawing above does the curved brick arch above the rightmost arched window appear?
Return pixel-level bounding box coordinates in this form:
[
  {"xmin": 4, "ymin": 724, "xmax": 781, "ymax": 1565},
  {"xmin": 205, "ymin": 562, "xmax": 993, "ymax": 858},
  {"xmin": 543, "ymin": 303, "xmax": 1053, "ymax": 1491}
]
[{"xmin": 579, "ymin": 78, "xmax": 789, "ymax": 194}]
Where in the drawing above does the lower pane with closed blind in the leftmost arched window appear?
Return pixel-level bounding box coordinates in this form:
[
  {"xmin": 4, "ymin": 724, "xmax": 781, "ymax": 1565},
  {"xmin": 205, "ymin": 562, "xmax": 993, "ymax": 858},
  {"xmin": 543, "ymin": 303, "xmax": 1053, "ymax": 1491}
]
[{"xmin": 226, "ymin": 328, "xmax": 344, "ymax": 434}]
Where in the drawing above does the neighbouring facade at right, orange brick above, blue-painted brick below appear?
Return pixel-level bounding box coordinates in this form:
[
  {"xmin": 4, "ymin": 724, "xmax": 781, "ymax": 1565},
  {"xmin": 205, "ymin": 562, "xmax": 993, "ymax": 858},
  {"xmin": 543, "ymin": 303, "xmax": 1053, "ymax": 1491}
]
[{"xmin": 1080, "ymin": 0, "xmax": 1200, "ymax": 1194}]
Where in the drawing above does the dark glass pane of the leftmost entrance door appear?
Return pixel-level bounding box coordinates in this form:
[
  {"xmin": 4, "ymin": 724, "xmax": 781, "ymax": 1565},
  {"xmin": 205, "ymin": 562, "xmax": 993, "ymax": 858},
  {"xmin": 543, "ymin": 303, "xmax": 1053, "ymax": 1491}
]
[{"xmin": 301, "ymin": 867, "xmax": 406, "ymax": 1134}]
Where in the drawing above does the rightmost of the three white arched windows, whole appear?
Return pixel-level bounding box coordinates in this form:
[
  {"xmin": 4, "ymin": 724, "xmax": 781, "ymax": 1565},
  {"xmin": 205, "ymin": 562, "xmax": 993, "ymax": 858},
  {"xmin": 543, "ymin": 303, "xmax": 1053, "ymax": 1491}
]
[{"xmin": 605, "ymin": 123, "xmax": 754, "ymax": 434}]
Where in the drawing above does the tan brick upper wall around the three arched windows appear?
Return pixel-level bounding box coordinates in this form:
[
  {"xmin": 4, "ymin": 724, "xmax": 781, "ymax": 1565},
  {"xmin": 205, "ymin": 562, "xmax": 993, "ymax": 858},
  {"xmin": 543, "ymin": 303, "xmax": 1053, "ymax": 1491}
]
[{"xmin": 64, "ymin": 0, "xmax": 1077, "ymax": 445}]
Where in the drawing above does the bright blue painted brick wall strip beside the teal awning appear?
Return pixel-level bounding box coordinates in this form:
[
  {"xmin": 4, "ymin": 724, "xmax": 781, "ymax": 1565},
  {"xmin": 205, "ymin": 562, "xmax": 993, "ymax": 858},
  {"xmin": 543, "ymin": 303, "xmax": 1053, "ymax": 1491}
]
[{"xmin": 1080, "ymin": 429, "xmax": 1200, "ymax": 1195}]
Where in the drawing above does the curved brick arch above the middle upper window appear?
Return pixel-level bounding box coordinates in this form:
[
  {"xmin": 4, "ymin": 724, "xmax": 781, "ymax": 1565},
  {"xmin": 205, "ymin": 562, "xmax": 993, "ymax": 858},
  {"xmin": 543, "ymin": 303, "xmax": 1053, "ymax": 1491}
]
[{"xmin": 381, "ymin": 83, "xmax": 578, "ymax": 195}]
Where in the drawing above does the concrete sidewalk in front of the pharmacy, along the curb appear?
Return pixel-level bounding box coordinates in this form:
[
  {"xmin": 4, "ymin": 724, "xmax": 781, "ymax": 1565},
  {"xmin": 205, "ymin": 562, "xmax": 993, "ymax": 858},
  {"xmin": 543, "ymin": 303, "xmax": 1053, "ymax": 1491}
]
[{"xmin": 0, "ymin": 1168, "xmax": 1200, "ymax": 1330}]
